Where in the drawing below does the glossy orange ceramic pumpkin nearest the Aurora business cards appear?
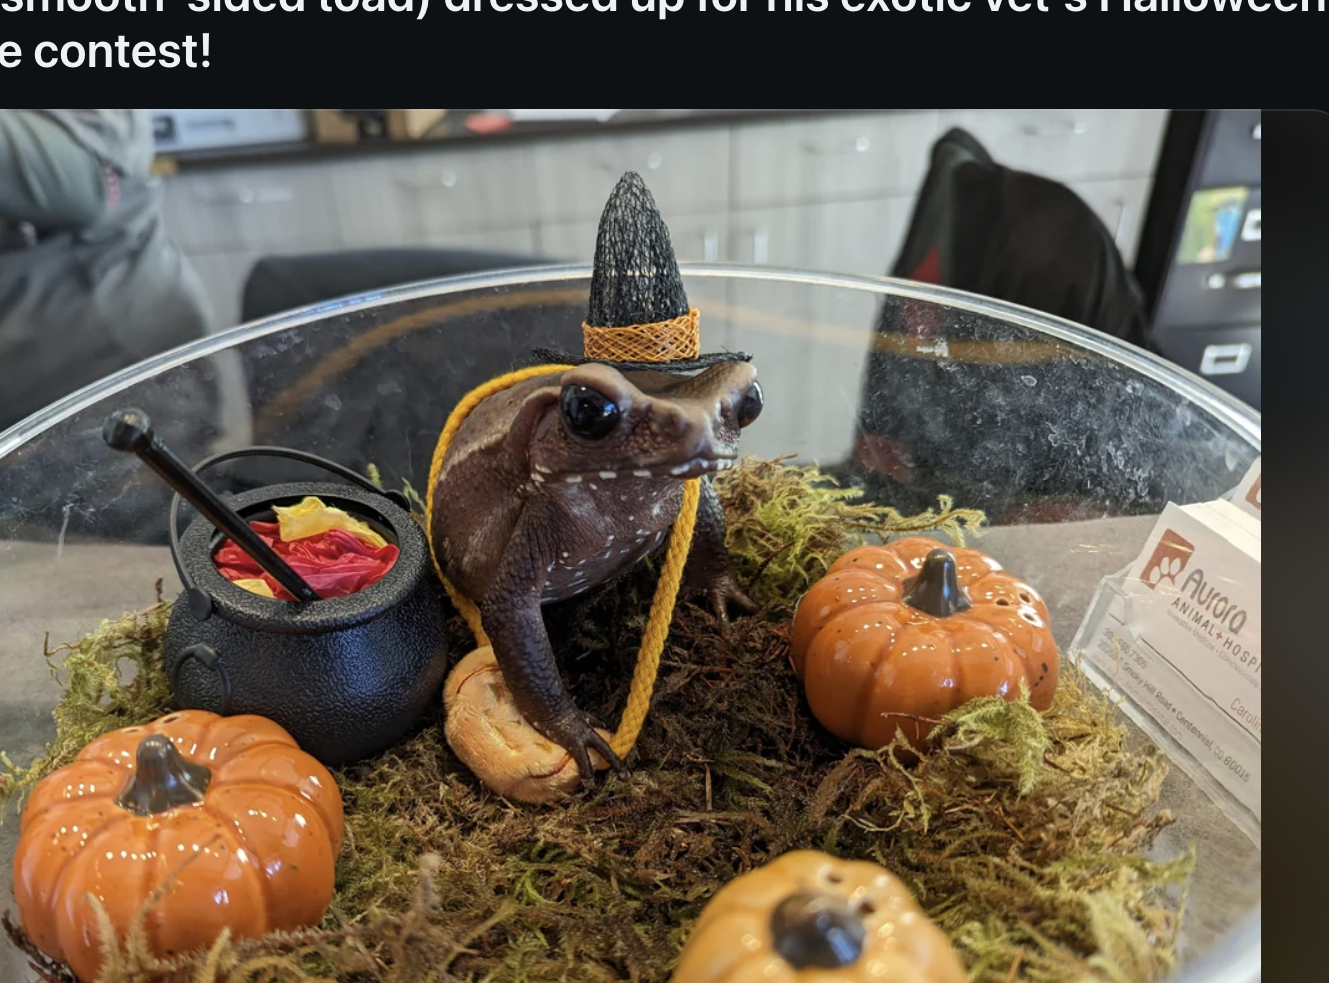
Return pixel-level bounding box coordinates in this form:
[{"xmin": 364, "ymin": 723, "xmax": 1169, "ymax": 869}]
[{"xmin": 792, "ymin": 537, "xmax": 1059, "ymax": 748}]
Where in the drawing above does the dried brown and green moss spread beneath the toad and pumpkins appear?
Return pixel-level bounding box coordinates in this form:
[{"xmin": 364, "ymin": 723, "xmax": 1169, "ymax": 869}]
[{"xmin": 0, "ymin": 462, "xmax": 1192, "ymax": 983}]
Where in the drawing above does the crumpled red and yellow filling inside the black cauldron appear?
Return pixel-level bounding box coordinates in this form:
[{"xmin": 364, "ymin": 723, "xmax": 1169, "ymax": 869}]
[{"xmin": 214, "ymin": 522, "xmax": 399, "ymax": 600}]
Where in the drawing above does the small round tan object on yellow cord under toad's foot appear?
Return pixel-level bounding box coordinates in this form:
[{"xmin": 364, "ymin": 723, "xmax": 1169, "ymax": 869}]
[{"xmin": 443, "ymin": 646, "xmax": 613, "ymax": 802}]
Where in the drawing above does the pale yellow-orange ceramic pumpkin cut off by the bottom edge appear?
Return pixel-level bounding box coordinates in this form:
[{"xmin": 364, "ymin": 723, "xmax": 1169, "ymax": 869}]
[{"xmin": 672, "ymin": 850, "xmax": 965, "ymax": 983}]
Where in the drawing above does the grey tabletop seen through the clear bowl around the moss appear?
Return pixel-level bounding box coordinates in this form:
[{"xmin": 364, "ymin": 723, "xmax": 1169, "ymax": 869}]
[{"xmin": 0, "ymin": 517, "xmax": 1261, "ymax": 980}]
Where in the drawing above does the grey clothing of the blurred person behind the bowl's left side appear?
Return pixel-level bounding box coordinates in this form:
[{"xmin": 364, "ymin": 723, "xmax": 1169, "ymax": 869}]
[{"xmin": 0, "ymin": 109, "xmax": 247, "ymax": 549}]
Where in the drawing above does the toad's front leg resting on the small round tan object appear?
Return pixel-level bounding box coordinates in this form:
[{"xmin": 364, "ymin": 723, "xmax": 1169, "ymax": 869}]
[{"xmin": 478, "ymin": 510, "xmax": 627, "ymax": 788}]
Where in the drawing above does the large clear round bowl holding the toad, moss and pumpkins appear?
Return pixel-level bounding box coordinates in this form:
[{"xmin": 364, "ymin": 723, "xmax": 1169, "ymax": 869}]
[{"xmin": 0, "ymin": 264, "xmax": 1260, "ymax": 983}]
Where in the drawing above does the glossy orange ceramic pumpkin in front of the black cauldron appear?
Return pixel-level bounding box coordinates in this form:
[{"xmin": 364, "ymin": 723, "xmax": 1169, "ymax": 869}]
[{"xmin": 13, "ymin": 711, "xmax": 343, "ymax": 980}]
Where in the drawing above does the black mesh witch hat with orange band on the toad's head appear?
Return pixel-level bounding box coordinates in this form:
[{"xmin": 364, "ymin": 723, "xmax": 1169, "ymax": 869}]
[{"xmin": 536, "ymin": 171, "xmax": 752, "ymax": 372}]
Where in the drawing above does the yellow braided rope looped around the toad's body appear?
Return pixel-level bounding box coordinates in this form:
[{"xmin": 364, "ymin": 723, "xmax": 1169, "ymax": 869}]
[{"xmin": 424, "ymin": 365, "xmax": 702, "ymax": 757}]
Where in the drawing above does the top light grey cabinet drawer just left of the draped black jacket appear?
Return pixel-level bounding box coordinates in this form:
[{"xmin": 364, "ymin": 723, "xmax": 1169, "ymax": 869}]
[{"xmin": 734, "ymin": 112, "xmax": 937, "ymax": 207}]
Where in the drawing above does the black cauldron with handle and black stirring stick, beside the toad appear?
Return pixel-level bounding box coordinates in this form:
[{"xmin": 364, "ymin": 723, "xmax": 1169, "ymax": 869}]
[{"xmin": 106, "ymin": 410, "xmax": 448, "ymax": 766}]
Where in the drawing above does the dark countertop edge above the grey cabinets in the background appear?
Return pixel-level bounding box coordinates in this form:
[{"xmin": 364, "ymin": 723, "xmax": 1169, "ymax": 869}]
[{"xmin": 158, "ymin": 109, "xmax": 882, "ymax": 171}]
